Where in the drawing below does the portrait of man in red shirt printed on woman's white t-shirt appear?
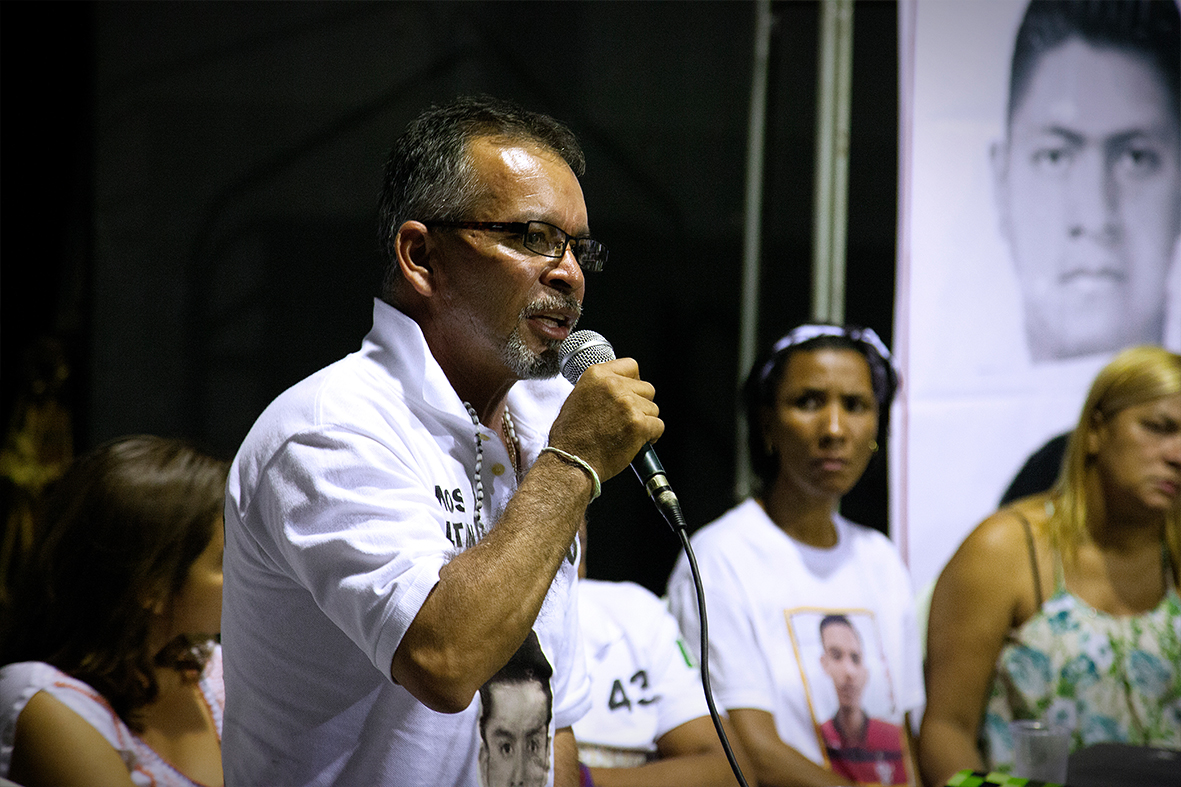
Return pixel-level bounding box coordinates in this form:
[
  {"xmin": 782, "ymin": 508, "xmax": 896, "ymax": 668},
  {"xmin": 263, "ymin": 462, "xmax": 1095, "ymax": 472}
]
[{"xmin": 788, "ymin": 609, "xmax": 908, "ymax": 785}]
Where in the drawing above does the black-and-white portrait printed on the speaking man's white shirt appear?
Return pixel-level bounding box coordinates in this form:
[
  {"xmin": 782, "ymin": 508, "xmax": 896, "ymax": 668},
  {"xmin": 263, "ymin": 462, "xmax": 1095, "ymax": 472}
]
[{"xmin": 479, "ymin": 631, "xmax": 554, "ymax": 787}]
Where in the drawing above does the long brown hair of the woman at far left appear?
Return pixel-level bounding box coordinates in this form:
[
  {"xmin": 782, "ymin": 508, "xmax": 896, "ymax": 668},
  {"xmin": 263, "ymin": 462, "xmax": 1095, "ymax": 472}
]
[{"xmin": 0, "ymin": 435, "xmax": 229, "ymax": 729}]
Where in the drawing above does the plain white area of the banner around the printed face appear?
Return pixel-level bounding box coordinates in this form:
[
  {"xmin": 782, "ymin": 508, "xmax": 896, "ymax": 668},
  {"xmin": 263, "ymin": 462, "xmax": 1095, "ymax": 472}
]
[{"xmin": 890, "ymin": 0, "xmax": 1181, "ymax": 590}]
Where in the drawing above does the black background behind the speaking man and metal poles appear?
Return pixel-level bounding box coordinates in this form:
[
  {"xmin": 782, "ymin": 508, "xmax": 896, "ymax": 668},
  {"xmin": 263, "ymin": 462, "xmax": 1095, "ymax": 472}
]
[{"xmin": 0, "ymin": 0, "xmax": 898, "ymax": 592}]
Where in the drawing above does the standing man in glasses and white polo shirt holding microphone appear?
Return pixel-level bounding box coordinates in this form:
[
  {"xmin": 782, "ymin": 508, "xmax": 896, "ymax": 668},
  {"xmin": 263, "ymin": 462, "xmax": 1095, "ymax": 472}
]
[{"xmin": 222, "ymin": 98, "xmax": 664, "ymax": 787}]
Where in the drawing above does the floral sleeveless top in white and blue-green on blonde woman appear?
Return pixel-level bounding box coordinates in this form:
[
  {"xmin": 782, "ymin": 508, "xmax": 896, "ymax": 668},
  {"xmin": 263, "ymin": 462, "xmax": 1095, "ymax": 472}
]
[{"xmin": 979, "ymin": 543, "xmax": 1181, "ymax": 770}]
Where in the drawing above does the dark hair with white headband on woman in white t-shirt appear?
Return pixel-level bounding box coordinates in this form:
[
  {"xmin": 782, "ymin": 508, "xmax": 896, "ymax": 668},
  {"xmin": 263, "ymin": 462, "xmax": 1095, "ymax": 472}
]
[{"xmin": 743, "ymin": 324, "xmax": 899, "ymax": 489}]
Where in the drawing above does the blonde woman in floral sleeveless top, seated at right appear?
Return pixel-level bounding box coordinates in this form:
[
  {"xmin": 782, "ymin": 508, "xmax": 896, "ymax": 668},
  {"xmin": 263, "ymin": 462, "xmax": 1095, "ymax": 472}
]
[{"xmin": 919, "ymin": 346, "xmax": 1181, "ymax": 785}]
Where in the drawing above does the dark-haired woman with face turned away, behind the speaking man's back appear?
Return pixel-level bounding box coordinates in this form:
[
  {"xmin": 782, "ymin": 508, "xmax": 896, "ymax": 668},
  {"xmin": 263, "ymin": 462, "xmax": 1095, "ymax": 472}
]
[{"xmin": 0, "ymin": 436, "xmax": 228, "ymax": 787}]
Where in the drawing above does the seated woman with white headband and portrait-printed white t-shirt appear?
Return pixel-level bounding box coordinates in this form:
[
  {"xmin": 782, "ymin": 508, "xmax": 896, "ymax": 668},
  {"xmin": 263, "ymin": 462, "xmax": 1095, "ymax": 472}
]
[{"xmin": 668, "ymin": 325, "xmax": 922, "ymax": 786}]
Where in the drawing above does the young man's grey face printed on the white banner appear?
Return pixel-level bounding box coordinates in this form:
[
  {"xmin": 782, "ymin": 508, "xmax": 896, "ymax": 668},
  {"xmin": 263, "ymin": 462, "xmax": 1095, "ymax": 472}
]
[{"xmin": 993, "ymin": 38, "xmax": 1181, "ymax": 362}]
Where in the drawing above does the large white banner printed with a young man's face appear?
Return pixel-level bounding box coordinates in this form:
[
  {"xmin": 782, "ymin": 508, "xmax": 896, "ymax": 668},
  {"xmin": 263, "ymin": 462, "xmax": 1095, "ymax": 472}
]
[{"xmin": 890, "ymin": 0, "xmax": 1181, "ymax": 588}]
